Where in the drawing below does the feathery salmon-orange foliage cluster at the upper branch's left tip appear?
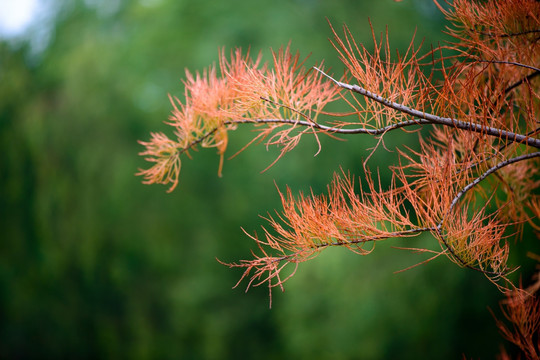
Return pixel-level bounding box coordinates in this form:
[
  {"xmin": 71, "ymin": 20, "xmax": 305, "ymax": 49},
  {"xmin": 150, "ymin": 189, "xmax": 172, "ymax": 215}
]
[{"xmin": 138, "ymin": 47, "xmax": 338, "ymax": 192}]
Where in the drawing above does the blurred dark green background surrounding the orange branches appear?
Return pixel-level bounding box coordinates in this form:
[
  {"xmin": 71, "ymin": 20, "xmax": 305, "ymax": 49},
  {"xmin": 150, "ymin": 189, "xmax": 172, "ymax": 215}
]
[{"xmin": 0, "ymin": 0, "xmax": 524, "ymax": 359}]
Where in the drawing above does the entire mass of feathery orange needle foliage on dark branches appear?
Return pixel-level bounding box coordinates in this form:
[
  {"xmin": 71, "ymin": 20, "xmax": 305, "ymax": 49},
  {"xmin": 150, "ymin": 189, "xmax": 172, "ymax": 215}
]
[{"xmin": 138, "ymin": 0, "xmax": 540, "ymax": 358}]
